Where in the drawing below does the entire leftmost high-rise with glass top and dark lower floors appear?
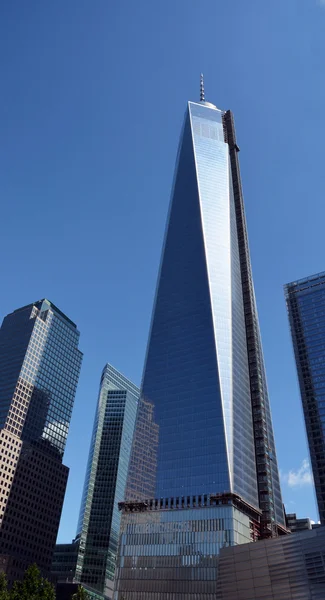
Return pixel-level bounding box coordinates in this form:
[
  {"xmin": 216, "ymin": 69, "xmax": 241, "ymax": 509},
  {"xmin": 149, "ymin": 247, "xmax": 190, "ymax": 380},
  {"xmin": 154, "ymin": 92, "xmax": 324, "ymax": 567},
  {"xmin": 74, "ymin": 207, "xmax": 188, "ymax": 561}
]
[{"xmin": 0, "ymin": 300, "xmax": 82, "ymax": 582}]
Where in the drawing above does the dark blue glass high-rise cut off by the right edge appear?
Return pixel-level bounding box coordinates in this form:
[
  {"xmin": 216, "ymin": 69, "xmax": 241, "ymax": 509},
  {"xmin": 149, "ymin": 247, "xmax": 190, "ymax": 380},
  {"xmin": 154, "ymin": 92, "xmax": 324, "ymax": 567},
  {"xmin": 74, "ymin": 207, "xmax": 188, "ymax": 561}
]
[{"xmin": 285, "ymin": 273, "xmax": 325, "ymax": 525}]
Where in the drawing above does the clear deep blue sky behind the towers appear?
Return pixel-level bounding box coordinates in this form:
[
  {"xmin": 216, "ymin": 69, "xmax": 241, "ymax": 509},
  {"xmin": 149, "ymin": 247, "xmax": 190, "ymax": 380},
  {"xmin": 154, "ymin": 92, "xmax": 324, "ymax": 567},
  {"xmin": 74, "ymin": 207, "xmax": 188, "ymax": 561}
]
[{"xmin": 0, "ymin": 0, "xmax": 325, "ymax": 541}]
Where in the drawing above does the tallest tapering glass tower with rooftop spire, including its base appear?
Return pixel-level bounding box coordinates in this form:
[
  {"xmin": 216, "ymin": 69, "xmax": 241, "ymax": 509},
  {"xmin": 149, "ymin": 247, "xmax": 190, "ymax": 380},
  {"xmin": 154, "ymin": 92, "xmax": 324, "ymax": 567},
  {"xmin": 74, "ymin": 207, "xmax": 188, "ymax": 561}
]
[{"xmin": 116, "ymin": 81, "xmax": 285, "ymax": 600}]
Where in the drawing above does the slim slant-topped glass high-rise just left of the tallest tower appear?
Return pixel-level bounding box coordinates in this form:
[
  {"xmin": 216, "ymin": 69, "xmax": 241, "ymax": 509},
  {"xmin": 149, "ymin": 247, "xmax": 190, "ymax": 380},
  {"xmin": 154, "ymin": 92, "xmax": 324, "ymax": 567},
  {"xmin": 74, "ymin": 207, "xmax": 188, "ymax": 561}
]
[{"xmin": 72, "ymin": 365, "xmax": 140, "ymax": 598}]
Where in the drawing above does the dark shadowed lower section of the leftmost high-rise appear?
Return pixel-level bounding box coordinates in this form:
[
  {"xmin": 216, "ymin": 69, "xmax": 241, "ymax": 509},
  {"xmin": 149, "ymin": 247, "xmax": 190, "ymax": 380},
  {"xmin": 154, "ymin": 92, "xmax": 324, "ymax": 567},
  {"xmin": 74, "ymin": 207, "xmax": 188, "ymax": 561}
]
[{"xmin": 0, "ymin": 432, "xmax": 69, "ymax": 585}]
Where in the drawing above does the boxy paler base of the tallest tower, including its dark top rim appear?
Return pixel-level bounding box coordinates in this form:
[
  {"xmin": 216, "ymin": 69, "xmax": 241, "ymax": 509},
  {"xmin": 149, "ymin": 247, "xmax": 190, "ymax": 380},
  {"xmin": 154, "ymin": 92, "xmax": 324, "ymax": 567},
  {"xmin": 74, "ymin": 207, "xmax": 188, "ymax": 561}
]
[{"xmin": 114, "ymin": 493, "xmax": 285, "ymax": 600}]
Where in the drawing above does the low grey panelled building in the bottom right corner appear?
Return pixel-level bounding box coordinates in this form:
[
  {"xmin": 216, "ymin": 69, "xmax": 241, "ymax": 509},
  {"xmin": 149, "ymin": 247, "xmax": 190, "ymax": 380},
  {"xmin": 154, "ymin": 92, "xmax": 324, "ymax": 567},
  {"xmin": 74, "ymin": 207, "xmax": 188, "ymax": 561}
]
[{"xmin": 215, "ymin": 527, "xmax": 325, "ymax": 600}]
